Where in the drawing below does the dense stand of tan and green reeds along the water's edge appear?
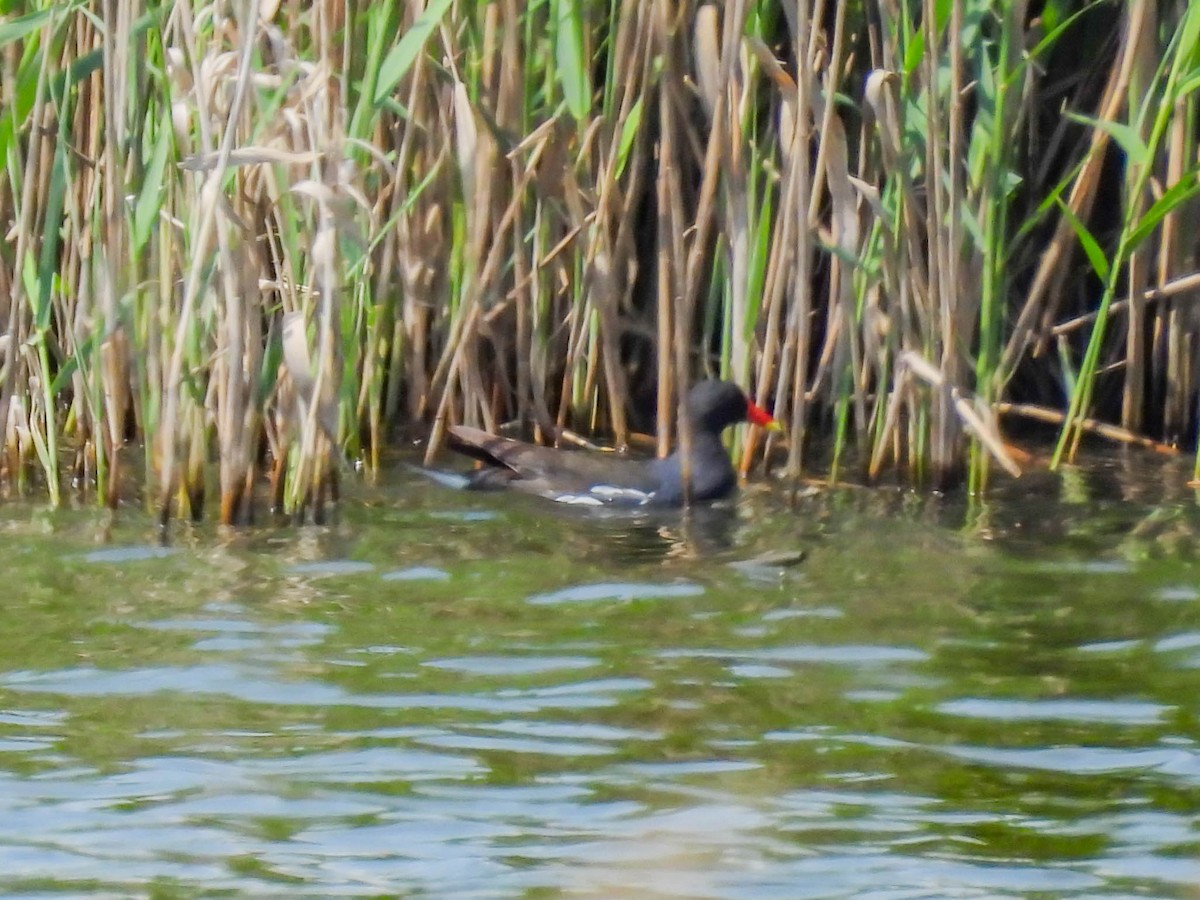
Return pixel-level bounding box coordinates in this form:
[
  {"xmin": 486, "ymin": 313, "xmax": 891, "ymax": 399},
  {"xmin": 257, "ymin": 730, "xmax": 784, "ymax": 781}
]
[{"xmin": 0, "ymin": 0, "xmax": 1200, "ymax": 523}]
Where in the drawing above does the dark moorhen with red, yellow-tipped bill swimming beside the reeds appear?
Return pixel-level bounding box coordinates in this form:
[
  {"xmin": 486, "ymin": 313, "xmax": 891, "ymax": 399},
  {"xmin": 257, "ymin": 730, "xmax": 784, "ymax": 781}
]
[{"xmin": 449, "ymin": 380, "xmax": 781, "ymax": 506}]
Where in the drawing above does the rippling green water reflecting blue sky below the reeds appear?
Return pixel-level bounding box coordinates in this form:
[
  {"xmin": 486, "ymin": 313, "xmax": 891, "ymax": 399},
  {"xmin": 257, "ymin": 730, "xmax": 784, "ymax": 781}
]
[{"xmin": 0, "ymin": 463, "xmax": 1200, "ymax": 898}]
